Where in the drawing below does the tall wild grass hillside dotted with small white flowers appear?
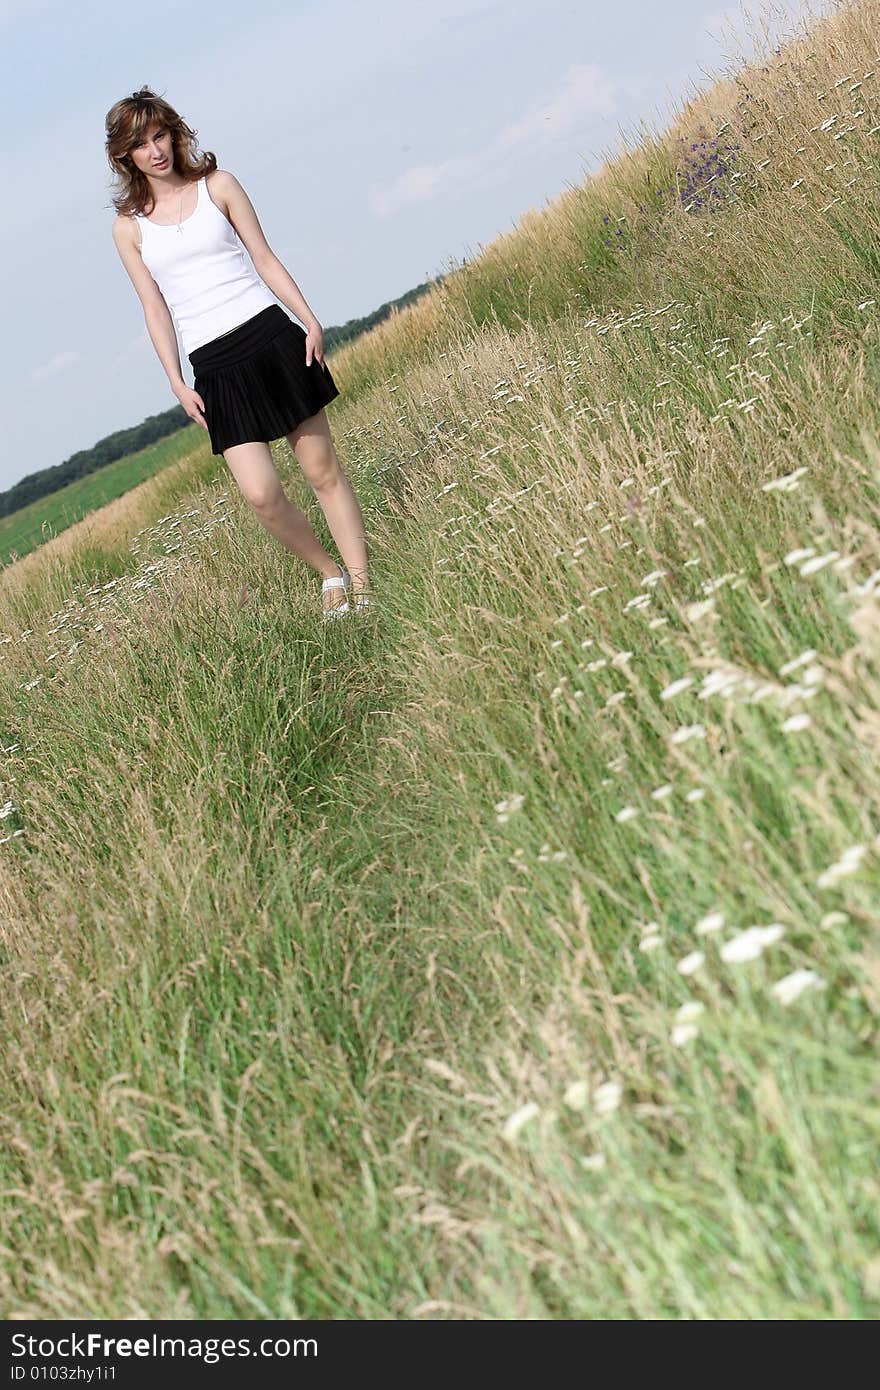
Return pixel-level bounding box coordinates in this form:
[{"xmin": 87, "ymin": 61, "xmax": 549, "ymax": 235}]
[{"xmin": 0, "ymin": 0, "xmax": 880, "ymax": 1319}]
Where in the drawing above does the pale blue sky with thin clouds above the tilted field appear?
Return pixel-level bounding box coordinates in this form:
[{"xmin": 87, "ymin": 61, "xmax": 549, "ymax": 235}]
[{"xmin": 0, "ymin": 0, "xmax": 841, "ymax": 491}]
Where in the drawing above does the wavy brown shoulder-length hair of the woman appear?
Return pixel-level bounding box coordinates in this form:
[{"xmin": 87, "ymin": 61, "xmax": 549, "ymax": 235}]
[{"xmin": 104, "ymin": 86, "xmax": 217, "ymax": 217}]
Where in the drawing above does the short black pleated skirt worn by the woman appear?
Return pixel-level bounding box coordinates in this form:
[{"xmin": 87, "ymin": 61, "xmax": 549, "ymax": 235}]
[{"xmin": 189, "ymin": 304, "xmax": 339, "ymax": 455}]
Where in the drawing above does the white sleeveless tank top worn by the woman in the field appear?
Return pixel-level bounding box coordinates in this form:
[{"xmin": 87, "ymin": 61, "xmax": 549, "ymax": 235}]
[{"xmin": 135, "ymin": 178, "xmax": 278, "ymax": 356}]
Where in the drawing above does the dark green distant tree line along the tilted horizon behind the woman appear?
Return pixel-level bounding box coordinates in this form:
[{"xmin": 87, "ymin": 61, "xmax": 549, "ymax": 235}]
[{"xmin": 0, "ymin": 275, "xmax": 445, "ymax": 517}]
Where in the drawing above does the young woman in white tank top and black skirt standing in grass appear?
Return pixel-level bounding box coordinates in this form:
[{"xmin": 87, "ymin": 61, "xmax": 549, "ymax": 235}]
[{"xmin": 106, "ymin": 86, "xmax": 371, "ymax": 620}]
